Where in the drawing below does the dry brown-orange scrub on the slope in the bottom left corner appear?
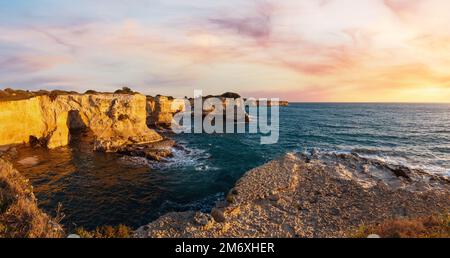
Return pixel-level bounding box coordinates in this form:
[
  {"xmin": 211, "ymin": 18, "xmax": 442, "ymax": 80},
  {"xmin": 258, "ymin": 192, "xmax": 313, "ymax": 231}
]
[{"xmin": 0, "ymin": 159, "xmax": 64, "ymax": 238}]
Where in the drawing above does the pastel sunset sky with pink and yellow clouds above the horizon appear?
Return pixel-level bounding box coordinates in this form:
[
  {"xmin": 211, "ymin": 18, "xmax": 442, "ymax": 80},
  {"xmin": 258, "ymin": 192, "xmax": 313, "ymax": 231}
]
[{"xmin": 0, "ymin": 0, "xmax": 450, "ymax": 102}]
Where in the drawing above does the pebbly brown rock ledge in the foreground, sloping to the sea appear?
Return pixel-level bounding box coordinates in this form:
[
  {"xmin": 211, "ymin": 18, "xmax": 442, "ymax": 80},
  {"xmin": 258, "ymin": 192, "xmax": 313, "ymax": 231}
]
[{"xmin": 135, "ymin": 151, "xmax": 450, "ymax": 237}]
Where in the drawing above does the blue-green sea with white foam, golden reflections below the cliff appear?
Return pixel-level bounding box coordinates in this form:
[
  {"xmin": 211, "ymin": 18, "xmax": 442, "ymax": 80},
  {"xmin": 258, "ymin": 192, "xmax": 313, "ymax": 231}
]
[{"xmin": 16, "ymin": 104, "xmax": 450, "ymax": 228}]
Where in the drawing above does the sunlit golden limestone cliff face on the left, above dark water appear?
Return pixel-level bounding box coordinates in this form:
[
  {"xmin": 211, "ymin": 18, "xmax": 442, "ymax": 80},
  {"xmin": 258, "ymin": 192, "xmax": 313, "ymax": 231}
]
[{"xmin": 0, "ymin": 94, "xmax": 162, "ymax": 151}]
